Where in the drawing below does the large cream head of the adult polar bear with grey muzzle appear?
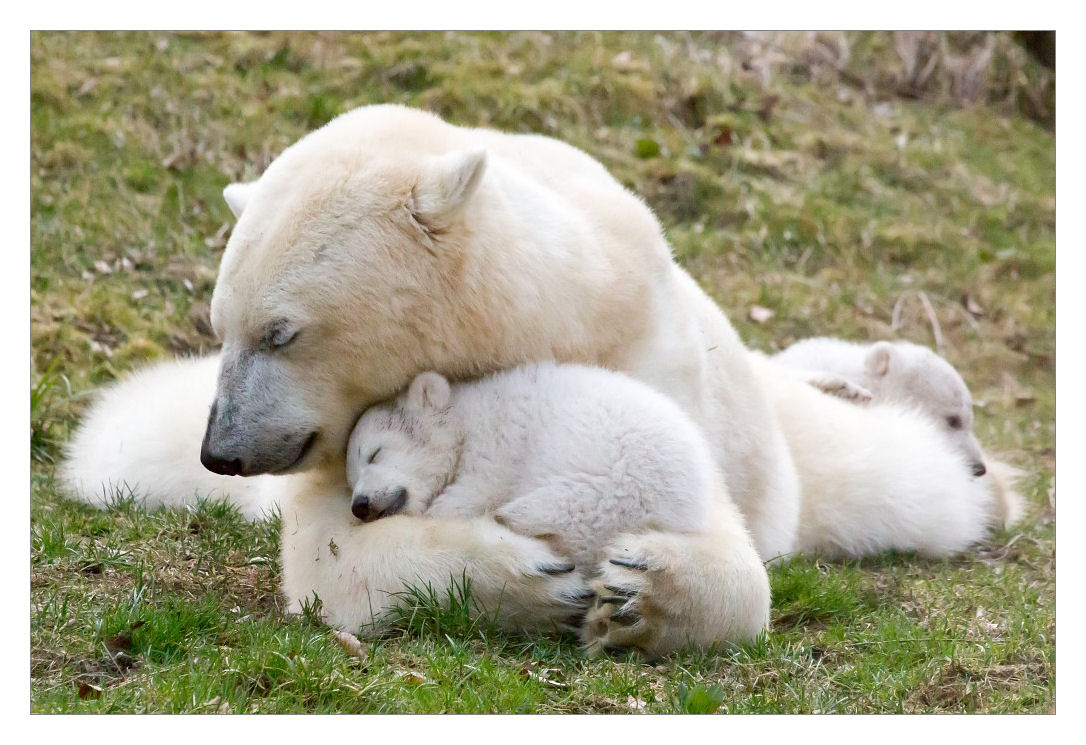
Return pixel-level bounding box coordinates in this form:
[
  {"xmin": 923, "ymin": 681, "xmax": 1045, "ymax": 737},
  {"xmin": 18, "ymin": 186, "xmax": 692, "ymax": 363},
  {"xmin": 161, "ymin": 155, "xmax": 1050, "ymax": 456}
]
[{"xmin": 201, "ymin": 106, "xmax": 485, "ymax": 476}]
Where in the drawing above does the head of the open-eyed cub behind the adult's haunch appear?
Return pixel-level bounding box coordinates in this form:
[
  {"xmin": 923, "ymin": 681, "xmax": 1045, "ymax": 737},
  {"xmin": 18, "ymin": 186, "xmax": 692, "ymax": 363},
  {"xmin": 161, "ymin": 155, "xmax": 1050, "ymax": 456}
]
[{"xmin": 864, "ymin": 341, "xmax": 987, "ymax": 476}]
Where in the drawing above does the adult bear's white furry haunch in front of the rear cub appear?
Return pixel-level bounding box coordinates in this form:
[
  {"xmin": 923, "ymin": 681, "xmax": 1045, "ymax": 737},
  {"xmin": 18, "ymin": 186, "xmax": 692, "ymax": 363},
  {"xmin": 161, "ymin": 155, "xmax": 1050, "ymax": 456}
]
[{"xmin": 752, "ymin": 353, "xmax": 998, "ymax": 556}]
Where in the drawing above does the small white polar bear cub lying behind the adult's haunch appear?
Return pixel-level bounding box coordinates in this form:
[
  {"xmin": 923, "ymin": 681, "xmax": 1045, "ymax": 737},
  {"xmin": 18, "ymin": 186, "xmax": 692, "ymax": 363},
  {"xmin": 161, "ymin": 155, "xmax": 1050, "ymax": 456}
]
[{"xmin": 773, "ymin": 337, "xmax": 987, "ymax": 476}]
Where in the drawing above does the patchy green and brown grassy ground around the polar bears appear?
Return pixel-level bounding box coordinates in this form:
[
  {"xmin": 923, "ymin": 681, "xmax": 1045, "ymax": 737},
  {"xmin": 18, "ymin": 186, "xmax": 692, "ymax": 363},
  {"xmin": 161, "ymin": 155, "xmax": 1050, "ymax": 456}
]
[{"xmin": 30, "ymin": 33, "xmax": 1056, "ymax": 712}]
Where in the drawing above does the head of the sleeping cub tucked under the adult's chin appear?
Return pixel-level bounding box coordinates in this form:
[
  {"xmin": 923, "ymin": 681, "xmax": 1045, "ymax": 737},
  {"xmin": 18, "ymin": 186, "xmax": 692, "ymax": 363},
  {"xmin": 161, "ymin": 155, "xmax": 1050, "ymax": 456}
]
[{"xmin": 346, "ymin": 373, "xmax": 460, "ymax": 522}]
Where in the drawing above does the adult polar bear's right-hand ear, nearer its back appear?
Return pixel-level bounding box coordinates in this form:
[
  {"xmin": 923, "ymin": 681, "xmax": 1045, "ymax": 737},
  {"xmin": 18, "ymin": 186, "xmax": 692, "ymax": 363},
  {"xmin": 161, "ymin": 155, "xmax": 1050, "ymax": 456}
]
[{"xmin": 411, "ymin": 148, "xmax": 487, "ymax": 231}]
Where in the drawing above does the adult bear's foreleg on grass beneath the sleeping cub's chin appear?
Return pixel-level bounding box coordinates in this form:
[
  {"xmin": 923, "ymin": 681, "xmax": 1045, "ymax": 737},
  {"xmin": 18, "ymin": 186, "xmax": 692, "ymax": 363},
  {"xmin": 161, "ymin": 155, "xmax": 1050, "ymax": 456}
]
[{"xmin": 280, "ymin": 490, "xmax": 591, "ymax": 632}]
